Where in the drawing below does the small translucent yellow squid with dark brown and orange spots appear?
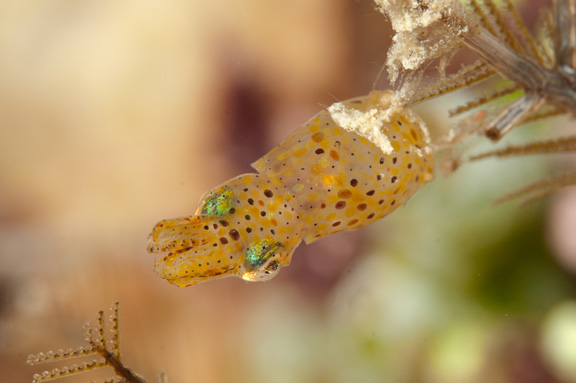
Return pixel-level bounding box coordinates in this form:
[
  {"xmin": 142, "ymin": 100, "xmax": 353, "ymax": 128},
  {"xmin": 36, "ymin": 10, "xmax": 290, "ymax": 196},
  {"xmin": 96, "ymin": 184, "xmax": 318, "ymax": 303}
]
[{"xmin": 148, "ymin": 91, "xmax": 433, "ymax": 286}]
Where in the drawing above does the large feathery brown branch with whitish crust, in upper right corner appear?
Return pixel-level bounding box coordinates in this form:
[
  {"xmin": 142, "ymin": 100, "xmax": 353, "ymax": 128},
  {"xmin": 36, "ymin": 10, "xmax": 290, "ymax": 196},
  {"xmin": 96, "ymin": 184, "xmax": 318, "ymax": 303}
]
[{"xmin": 375, "ymin": 0, "xmax": 576, "ymax": 202}]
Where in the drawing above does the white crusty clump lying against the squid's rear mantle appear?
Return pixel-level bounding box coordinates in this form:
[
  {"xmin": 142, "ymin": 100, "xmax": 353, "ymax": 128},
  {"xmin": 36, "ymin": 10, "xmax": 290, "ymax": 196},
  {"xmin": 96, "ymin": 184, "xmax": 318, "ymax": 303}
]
[{"xmin": 328, "ymin": 102, "xmax": 394, "ymax": 154}]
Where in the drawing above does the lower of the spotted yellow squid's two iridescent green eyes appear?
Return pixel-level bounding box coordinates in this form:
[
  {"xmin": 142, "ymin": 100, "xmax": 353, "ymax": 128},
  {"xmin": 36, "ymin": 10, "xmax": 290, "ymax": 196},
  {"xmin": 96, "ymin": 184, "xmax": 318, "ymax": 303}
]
[{"xmin": 242, "ymin": 239, "xmax": 283, "ymax": 281}]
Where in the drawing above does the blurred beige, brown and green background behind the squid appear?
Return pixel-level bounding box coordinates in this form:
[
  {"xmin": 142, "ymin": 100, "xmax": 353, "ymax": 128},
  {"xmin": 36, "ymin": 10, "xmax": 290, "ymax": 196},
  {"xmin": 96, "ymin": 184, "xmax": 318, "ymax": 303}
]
[{"xmin": 0, "ymin": 0, "xmax": 576, "ymax": 383}]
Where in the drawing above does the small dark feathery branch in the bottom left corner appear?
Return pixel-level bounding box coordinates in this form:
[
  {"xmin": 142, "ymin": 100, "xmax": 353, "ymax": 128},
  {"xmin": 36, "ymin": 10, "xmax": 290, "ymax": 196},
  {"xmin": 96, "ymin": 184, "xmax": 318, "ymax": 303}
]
[{"xmin": 26, "ymin": 302, "xmax": 146, "ymax": 383}]
